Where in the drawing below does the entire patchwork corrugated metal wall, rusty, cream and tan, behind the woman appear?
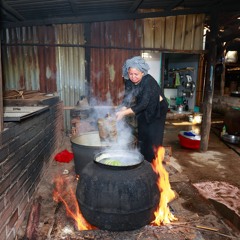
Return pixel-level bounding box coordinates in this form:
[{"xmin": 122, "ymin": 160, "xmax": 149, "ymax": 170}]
[{"xmin": 2, "ymin": 14, "xmax": 204, "ymax": 129}]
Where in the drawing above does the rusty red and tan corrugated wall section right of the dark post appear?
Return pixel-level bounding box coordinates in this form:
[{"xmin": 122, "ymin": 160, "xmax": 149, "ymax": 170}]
[{"xmin": 90, "ymin": 14, "xmax": 205, "ymax": 105}]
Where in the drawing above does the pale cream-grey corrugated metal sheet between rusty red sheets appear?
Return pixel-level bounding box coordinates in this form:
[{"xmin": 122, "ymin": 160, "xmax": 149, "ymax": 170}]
[{"xmin": 55, "ymin": 24, "xmax": 87, "ymax": 130}]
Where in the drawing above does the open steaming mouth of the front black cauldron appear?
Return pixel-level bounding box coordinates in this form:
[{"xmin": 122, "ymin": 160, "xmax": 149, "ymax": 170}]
[{"xmin": 94, "ymin": 150, "xmax": 144, "ymax": 168}]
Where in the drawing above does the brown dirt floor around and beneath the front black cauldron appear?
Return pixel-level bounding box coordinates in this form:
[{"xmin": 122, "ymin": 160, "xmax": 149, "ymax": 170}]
[{"xmin": 17, "ymin": 113, "xmax": 240, "ymax": 240}]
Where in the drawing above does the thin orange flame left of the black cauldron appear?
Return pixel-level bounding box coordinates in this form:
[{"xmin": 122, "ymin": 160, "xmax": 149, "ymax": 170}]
[{"xmin": 53, "ymin": 176, "xmax": 94, "ymax": 230}]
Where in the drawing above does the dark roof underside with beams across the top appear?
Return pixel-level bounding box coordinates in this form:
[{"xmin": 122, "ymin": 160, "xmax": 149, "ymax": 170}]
[{"xmin": 0, "ymin": 0, "xmax": 240, "ymax": 44}]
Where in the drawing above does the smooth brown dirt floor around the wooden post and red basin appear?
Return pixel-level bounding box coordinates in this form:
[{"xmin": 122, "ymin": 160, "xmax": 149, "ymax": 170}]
[{"xmin": 164, "ymin": 115, "xmax": 240, "ymax": 188}]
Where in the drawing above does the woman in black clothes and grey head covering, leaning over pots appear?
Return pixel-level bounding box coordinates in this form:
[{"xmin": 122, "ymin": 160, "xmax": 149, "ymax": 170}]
[{"xmin": 116, "ymin": 56, "xmax": 168, "ymax": 162}]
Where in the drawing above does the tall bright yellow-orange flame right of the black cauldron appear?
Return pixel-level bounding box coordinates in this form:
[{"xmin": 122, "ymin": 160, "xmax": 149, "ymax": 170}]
[{"xmin": 152, "ymin": 147, "xmax": 177, "ymax": 226}]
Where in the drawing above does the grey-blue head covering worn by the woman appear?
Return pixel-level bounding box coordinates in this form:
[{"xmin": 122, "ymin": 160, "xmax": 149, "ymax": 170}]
[{"xmin": 122, "ymin": 56, "xmax": 150, "ymax": 79}]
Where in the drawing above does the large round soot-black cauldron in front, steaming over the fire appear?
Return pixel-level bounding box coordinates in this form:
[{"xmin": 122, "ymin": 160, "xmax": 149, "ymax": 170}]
[{"xmin": 76, "ymin": 151, "xmax": 160, "ymax": 231}]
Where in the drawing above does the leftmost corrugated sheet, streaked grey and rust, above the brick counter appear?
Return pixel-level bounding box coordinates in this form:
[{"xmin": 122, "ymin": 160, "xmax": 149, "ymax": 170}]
[{"xmin": 2, "ymin": 27, "xmax": 40, "ymax": 90}]
